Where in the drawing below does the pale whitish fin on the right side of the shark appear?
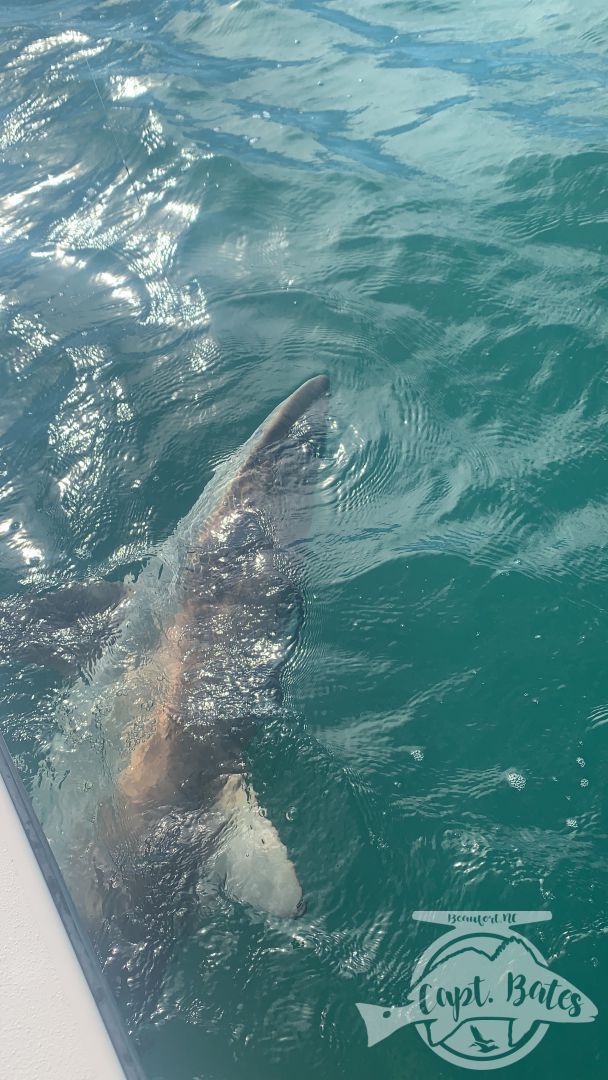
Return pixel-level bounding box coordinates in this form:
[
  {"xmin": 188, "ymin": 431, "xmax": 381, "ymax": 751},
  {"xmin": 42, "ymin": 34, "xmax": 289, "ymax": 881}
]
[{"xmin": 214, "ymin": 774, "xmax": 305, "ymax": 917}]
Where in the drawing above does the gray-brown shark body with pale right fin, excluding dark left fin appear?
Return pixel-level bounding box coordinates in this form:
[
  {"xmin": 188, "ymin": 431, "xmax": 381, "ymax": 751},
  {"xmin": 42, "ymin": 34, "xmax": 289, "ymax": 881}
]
[{"xmin": 35, "ymin": 376, "xmax": 328, "ymax": 940}]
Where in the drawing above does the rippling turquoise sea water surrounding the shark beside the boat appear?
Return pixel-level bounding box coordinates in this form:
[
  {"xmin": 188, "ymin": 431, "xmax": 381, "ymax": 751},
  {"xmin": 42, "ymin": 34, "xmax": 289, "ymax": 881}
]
[{"xmin": 0, "ymin": 0, "xmax": 608, "ymax": 1080}]
